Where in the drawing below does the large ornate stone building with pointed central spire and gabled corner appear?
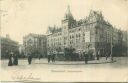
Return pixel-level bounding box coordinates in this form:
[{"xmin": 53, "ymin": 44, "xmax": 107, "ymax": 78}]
[{"xmin": 47, "ymin": 7, "xmax": 127, "ymax": 55}]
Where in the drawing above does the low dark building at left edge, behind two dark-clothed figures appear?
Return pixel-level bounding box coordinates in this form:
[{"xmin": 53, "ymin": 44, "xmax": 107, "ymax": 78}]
[{"xmin": 0, "ymin": 35, "xmax": 19, "ymax": 58}]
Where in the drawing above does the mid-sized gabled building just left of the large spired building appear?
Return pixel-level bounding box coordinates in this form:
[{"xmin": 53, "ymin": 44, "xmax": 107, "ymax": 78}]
[{"xmin": 23, "ymin": 33, "xmax": 47, "ymax": 57}]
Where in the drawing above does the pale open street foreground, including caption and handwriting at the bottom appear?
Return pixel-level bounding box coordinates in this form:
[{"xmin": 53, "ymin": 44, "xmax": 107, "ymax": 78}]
[{"xmin": 0, "ymin": 57, "xmax": 128, "ymax": 82}]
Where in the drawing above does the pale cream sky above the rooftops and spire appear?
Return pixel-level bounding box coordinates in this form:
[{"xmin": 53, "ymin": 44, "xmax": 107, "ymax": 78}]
[{"xmin": 0, "ymin": 0, "xmax": 128, "ymax": 43}]
